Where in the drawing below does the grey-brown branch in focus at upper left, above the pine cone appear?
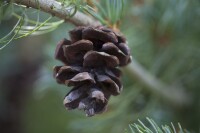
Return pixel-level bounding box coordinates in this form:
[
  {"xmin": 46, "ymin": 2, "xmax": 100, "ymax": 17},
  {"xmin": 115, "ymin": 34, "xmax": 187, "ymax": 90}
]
[{"xmin": 13, "ymin": 0, "xmax": 100, "ymax": 26}]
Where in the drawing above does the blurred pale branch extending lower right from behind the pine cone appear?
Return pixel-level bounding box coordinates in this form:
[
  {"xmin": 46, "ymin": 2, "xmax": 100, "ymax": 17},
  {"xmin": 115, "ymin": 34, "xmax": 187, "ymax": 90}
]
[{"xmin": 123, "ymin": 59, "xmax": 191, "ymax": 107}]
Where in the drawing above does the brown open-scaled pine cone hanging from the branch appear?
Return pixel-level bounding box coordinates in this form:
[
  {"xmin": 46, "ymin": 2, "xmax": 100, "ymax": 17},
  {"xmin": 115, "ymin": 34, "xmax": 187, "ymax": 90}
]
[{"xmin": 54, "ymin": 26, "xmax": 131, "ymax": 116}]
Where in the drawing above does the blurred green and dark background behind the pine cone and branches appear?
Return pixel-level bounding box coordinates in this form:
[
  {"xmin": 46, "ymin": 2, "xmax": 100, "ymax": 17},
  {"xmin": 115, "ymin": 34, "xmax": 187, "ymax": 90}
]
[{"xmin": 0, "ymin": 0, "xmax": 200, "ymax": 133}]
